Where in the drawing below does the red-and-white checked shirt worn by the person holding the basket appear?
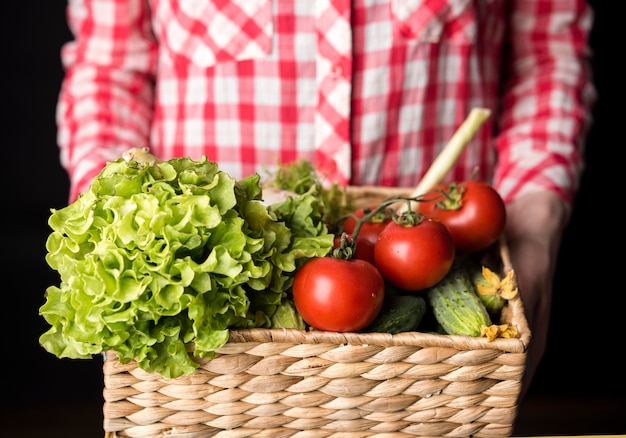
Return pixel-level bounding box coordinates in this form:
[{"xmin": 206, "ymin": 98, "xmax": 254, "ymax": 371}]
[{"xmin": 57, "ymin": 0, "xmax": 595, "ymax": 204}]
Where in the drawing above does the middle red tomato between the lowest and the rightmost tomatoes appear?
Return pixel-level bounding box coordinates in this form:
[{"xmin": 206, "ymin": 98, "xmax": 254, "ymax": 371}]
[{"xmin": 374, "ymin": 217, "xmax": 455, "ymax": 290}]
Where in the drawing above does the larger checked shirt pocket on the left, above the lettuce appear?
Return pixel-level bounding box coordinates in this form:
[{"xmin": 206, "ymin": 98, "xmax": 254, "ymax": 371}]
[{"xmin": 153, "ymin": 0, "xmax": 273, "ymax": 67}]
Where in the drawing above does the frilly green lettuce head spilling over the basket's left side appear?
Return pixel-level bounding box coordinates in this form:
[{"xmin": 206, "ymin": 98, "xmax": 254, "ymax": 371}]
[{"xmin": 39, "ymin": 157, "xmax": 334, "ymax": 378}]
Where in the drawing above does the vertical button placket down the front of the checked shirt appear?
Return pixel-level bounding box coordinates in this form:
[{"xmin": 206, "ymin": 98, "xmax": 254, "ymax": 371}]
[{"xmin": 315, "ymin": 0, "xmax": 352, "ymax": 184}]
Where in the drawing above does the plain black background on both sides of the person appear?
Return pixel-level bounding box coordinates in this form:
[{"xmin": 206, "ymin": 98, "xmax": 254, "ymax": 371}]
[{"xmin": 0, "ymin": 0, "xmax": 626, "ymax": 433}]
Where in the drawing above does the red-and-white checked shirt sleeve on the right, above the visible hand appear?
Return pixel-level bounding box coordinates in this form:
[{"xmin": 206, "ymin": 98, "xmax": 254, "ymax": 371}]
[{"xmin": 494, "ymin": 0, "xmax": 596, "ymax": 207}]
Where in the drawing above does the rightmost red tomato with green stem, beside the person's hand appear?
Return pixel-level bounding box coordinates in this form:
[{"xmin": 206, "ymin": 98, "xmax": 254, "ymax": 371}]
[{"xmin": 417, "ymin": 181, "xmax": 506, "ymax": 253}]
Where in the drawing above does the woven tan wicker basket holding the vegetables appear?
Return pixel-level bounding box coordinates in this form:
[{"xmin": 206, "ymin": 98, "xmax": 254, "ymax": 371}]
[{"xmin": 103, "ymin": 188, "xmax": 531, "ymax": 438}]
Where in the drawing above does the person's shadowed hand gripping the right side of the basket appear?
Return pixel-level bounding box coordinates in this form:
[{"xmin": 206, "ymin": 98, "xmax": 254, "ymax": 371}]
[{"xmin": 505, "ymin": 192, "xmax": 569, "ymax": 401}]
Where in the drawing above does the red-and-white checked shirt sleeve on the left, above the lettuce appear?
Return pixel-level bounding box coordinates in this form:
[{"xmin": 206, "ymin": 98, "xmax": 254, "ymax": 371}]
[{"xmin": 57, "ymin": 0, "xmax": 156, "ymax": 201}]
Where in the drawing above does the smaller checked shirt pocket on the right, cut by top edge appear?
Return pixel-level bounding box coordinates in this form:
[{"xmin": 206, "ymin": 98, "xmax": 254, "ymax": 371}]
[{"xmin": 390, "ymin": 0, "xmax": 477, "ymax": 44}]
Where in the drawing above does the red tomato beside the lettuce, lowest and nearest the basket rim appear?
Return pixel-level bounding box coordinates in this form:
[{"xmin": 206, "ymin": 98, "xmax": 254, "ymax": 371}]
[{"xmin": 293, "ymin": 257, "xmax": 385, "ymax": 332}]
